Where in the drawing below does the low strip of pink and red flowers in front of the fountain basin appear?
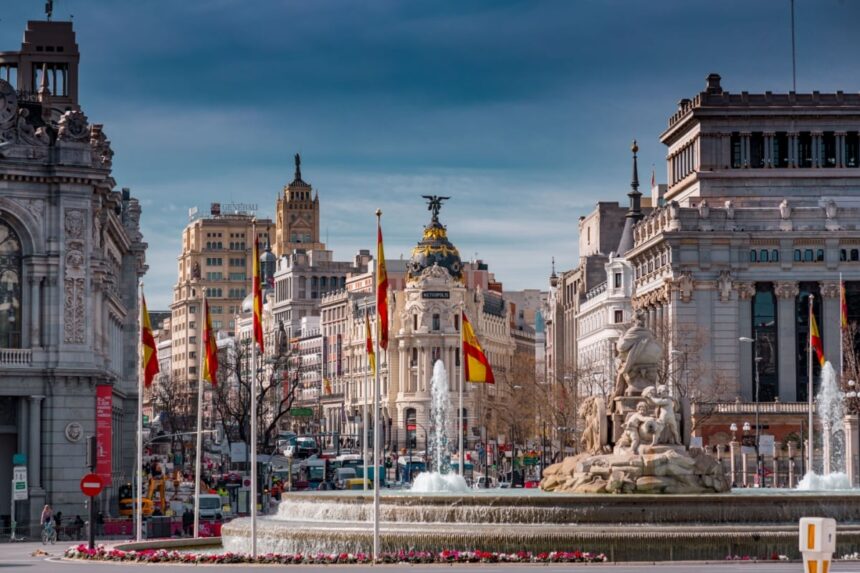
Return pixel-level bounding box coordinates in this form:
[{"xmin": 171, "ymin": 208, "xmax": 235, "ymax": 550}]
[{"xmin": 65, "ymin": 544, "xmax": 606, "ymax": 565}]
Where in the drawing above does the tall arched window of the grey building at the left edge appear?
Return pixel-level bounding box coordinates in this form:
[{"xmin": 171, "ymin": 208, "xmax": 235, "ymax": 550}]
[{"xmin": 0, "ymin": 220, "xmax": 22, "ymax": 348}]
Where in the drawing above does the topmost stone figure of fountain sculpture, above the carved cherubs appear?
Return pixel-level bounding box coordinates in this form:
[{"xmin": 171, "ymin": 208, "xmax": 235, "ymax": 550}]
[{"xmin": 609, "ymin": 311, "xmax": 663, "ymax": 405}]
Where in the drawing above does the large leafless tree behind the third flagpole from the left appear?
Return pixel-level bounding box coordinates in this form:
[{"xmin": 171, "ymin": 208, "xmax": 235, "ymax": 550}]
[{"xmin": 212, "ymin": 339, "xmax": 298, "ymax": 452}]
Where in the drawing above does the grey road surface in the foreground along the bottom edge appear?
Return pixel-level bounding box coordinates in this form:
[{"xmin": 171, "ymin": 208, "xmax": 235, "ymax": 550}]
[{"xmin": 0, "ymin": 543, "xmax": 860, "ymax": 573}]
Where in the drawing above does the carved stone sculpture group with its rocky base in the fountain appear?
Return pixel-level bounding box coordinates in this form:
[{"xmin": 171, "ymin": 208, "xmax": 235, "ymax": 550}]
[{"xmin": 541, "ymin": 314, "xmax": 730, "ymax": 494}]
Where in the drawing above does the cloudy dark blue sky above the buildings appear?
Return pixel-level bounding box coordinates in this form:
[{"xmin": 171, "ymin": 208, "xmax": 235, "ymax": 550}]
[{"xmin": 5, "ymin": 0, "xmax": 860, "ymax": 310}]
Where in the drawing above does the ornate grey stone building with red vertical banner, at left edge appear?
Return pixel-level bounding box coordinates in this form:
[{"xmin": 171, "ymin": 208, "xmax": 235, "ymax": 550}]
[{"xmin": 0, "ymin": 17, "xmax": 146, "ymax": 528}]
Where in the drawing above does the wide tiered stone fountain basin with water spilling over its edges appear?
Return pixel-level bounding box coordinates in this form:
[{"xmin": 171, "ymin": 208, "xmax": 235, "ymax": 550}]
[{"xmin": 222, "ymin": 490, "xmax": 860, "ymax": 561}]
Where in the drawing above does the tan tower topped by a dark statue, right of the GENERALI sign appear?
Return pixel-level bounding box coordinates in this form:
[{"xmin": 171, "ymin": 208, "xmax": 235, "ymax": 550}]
[{"xmin": 275, "ymin": 153, "xmax": 325, "ymax": 257}]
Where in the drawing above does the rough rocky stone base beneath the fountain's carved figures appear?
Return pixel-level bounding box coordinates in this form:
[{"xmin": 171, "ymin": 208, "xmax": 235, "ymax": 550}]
[{"xmin": 541, "ymin": 445, "xmax": 731, "ymax": 494}]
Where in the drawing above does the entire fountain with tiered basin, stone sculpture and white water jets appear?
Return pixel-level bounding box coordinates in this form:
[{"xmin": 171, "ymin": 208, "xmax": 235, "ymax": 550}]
[{"xmin": 133, "ymin": 316, "xmax": 860, "ymax": 561}]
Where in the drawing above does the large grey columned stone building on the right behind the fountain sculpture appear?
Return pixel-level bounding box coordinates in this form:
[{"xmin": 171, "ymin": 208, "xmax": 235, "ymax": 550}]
[{"xmin": 551, "ymin": 74, "xmax": 860, "ymax": 475}]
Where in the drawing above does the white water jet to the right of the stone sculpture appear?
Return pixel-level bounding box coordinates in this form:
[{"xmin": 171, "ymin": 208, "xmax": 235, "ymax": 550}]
[{"xmin": 797, "ymin": 361, "xmax": 851, "ymax": 491}]
